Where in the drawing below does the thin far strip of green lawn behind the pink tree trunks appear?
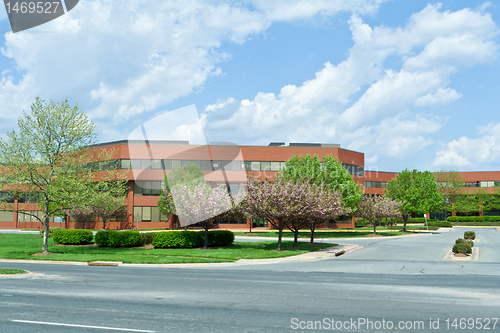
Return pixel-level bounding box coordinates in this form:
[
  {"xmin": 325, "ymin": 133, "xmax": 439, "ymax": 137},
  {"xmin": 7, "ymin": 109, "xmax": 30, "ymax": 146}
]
[{"xmin": 234, "ymin": 227, "xmax": 409, "ymax": 239}]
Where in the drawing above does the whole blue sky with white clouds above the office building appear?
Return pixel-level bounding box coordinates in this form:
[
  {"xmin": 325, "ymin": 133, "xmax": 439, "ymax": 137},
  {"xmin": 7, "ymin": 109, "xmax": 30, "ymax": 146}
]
[{"xmin": 0, "ymin": 0, "xmax": 500, "ymax": 171}]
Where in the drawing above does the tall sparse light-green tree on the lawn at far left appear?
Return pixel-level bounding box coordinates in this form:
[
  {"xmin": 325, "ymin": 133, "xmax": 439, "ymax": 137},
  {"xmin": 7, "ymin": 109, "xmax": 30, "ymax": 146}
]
[{"xmin": 0, "ymin": 98, "xmax": 118, "ymax": 253}]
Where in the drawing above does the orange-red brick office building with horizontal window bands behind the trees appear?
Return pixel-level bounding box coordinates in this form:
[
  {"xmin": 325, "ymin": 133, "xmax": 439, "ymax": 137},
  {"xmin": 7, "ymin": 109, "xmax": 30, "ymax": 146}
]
[{"xmin": 0, "ymin": 141, "xmax": 500, "ymax": 229}]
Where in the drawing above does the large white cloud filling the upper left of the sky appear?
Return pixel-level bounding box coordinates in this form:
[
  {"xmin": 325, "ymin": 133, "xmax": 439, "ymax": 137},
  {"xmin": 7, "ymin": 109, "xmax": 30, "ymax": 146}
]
[{"xmin": 0, "ymin": 0, "xmax": 383, "ymax": 137}]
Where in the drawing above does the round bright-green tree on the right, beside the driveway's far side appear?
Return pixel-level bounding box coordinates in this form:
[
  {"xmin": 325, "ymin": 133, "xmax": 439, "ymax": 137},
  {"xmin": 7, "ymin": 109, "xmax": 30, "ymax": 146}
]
[{"xmin": 385, "ymin": 169, "xmax": 443, "ymax": 231}]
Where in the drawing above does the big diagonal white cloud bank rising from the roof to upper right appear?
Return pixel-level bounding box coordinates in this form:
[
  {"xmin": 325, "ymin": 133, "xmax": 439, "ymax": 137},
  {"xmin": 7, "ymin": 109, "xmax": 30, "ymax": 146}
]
[{"xmin": 203, "ymin": 4, "xmax": 498, "ymax": 169}]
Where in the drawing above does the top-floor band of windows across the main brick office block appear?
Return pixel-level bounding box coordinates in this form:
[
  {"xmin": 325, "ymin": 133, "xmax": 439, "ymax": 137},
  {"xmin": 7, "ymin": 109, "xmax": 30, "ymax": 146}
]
[{"xmin": 88, "ymin": 159, "xmax": 364, "ymax": 176}]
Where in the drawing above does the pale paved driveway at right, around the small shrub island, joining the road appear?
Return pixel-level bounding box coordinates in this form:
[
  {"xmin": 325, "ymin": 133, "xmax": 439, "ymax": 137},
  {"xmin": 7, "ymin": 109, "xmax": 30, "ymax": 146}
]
[{"xmin": 231, "ymin": 227, "xmax": 500, "ymax": 275}]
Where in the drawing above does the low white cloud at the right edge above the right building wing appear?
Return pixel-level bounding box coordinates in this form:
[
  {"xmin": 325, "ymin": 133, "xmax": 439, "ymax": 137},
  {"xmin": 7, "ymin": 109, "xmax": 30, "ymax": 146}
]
[{"xmin": 432, "ymin": 123, "xmax": 500, "ymax": 170}]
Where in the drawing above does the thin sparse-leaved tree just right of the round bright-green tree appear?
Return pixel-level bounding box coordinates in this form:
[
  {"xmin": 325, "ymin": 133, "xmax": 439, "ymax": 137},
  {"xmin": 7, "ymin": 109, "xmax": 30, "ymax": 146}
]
[{"xmin": 434, "ymin": 169, "xmax": 465, "ymax": 220}]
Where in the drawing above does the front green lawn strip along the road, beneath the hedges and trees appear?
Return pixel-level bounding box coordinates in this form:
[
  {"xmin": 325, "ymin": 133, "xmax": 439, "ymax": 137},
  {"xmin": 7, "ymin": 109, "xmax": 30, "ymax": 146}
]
[{"xmin": 0, "ymin": 234, "xmax": 334, "ymax": 264}]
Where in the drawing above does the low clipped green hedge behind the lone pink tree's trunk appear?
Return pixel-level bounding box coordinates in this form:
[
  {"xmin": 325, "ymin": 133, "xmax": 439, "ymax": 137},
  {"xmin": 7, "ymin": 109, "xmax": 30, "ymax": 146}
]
[{"xmin": 153, "ymin": 230, "xmax": 234, "ymax": 249}]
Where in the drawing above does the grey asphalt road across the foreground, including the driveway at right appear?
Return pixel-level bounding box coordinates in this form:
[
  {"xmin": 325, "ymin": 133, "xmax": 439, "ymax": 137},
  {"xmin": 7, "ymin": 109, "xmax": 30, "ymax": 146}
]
[{"xmin": 0, "ymin": 228, "xmax": 500, "ymax": 332}]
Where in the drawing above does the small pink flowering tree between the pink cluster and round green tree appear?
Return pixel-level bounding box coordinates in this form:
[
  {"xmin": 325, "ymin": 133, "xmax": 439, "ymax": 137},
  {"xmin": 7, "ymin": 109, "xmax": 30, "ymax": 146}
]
[{"xmin": 356, "ymin": 195, "xmax": 403, "ymax": 234}]
